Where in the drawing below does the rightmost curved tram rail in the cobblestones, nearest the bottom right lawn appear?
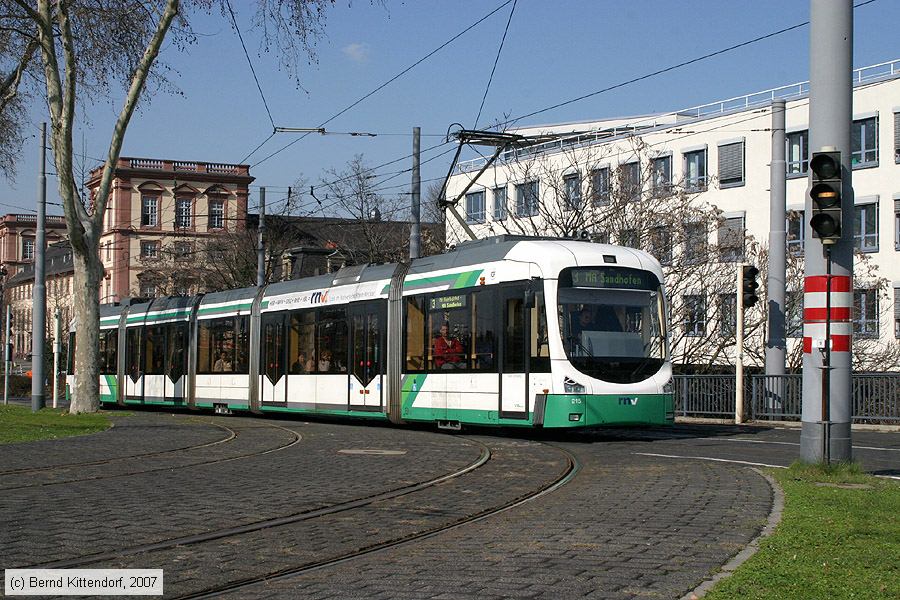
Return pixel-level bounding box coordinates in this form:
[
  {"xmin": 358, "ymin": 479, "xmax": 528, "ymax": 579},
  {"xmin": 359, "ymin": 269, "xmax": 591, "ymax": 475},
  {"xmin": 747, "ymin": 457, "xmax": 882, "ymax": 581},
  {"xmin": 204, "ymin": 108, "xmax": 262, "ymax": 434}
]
[{"xmin": 175, "ymin": 442, "xmax": 581, "ymax": 600}]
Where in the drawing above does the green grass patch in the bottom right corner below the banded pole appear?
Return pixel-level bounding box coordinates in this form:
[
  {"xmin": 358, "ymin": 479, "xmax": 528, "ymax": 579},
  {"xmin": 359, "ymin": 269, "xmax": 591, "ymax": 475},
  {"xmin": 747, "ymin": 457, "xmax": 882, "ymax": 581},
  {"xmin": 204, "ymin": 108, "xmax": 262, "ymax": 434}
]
[{"xmin": 706, "ymin": 465, "xmax": 900, "ymax": 600}]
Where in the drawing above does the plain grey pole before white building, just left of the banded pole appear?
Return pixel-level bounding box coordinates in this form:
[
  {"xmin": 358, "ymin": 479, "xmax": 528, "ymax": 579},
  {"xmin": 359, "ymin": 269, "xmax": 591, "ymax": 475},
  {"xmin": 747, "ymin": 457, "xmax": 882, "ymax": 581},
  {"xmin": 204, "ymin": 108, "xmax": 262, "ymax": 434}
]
[{"xmin": 766, "ymin": 100, "xmax": 787, "ymax": 378}]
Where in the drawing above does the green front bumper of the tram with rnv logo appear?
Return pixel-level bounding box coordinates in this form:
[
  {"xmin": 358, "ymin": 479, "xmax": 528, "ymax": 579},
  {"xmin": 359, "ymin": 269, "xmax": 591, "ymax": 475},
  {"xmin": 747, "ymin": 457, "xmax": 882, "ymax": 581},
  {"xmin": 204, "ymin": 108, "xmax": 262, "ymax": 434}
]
[{"xmin": 544, "ymin": 394, "xmax": 675, "ymax": 428}]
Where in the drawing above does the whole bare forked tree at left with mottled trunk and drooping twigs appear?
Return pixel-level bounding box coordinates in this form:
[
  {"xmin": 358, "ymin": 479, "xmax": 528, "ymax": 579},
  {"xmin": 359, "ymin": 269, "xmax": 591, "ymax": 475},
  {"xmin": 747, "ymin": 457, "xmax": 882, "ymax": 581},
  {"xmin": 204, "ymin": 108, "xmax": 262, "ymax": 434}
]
[{"xmin": 0, "ymin": 0, "xmax": 330, "ymax": 413}]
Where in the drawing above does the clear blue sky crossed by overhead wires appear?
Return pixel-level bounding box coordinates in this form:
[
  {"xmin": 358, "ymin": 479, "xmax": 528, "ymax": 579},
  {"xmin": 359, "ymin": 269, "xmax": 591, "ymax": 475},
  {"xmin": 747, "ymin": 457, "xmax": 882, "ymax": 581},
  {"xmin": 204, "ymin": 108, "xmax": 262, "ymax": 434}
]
[{"xmin": 0, "ymin": 0, "xmax": 900, "ymax": 214}]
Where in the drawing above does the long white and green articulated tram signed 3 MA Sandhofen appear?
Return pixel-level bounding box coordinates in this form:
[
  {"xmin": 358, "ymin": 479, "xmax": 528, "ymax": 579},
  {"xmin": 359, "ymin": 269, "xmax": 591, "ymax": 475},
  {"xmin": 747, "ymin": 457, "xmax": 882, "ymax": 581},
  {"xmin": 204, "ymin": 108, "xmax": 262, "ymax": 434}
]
[{"xmin": 67, "ymin": 235, "xmax": 674, "ymax": 429}]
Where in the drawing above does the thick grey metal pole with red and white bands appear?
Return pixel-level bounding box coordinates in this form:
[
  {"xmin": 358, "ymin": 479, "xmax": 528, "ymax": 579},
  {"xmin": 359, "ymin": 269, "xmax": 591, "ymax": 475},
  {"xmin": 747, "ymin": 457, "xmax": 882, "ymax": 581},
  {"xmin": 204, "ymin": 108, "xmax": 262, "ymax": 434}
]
[{"xmin": 800, "ymin": 0, "xmax": 854, "ymax": 463}]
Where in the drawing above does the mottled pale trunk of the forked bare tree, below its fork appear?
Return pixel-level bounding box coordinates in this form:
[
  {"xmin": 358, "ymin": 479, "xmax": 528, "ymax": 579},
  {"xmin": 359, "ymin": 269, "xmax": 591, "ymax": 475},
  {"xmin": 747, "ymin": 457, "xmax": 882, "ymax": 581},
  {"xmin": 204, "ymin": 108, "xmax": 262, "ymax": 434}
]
[{"xmin": 69, "ymin": 245, "xmax": 103, "ymax": 414}]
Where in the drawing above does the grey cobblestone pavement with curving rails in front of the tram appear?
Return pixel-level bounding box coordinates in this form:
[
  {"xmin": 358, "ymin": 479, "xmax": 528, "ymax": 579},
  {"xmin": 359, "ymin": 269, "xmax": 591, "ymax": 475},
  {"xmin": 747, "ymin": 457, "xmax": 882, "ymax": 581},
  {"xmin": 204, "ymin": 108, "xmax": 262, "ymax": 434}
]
[{"xmin": 0, "ymin": 413, "xmax": 900, "ymax": 598}]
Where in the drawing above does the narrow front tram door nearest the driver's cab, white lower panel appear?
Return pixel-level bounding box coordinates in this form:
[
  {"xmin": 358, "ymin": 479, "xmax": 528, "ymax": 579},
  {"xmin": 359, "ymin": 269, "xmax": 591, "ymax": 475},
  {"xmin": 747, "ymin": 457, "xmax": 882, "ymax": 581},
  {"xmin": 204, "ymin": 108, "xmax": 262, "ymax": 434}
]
[{"xmin": 499, "ymin": 288, "xmax": 529, "ymax": 419}]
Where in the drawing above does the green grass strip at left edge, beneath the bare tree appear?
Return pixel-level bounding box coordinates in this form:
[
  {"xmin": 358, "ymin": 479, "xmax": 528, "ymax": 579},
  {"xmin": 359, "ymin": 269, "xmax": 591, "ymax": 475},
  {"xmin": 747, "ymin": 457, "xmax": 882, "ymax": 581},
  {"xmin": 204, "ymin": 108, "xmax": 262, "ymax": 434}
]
[{"xmin": 0, "ymin": 405, "xmax": 110, "ymax": 444}]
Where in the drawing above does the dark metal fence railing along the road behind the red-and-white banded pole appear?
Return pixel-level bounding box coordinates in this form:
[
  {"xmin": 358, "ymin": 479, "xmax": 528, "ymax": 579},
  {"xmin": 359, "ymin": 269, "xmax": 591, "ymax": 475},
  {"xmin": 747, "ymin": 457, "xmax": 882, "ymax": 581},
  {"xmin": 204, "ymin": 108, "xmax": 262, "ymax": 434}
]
[{"xmin": 673, "ymin": 373, "xmax": 900, "ymax": 423}]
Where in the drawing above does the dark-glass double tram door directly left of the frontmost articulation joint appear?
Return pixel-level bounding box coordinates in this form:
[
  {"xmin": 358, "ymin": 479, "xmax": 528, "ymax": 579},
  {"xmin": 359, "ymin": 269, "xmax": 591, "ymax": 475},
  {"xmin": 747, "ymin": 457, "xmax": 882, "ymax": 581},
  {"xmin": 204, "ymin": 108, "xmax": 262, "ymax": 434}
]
[{"xmin": 348, "ymin": 302, "xmax": 386, "ymax": 412}]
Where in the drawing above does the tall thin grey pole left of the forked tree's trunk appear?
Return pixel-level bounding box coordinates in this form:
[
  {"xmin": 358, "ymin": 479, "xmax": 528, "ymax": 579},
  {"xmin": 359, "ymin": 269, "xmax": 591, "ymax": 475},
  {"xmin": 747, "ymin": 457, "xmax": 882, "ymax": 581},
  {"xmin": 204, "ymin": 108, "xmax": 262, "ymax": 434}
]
[{"xmin": 31, "ymin": 123, "xmax": 47, "ymax": 412}]
